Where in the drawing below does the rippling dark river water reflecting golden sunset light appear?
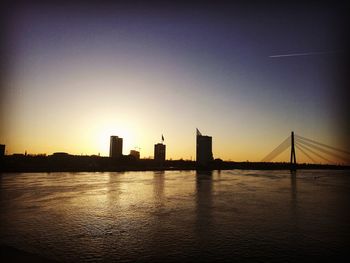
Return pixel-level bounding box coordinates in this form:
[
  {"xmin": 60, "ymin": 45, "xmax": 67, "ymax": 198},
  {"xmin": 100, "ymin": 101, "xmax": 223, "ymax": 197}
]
[{"xmin": 0, "ymin": 170, "xmax": 350, "ymax": 262}]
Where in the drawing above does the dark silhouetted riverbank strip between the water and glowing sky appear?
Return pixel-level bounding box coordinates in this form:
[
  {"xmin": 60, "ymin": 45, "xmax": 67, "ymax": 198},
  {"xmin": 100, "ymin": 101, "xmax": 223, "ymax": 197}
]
[{"xmin": 0, "ymin": 155, "xmax": 350, "ymax": 173}]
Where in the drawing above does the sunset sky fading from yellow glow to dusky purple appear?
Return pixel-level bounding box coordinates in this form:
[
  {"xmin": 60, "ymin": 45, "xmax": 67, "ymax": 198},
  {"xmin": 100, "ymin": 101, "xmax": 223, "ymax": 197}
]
[{"xmin": 0, "ymin": 2, "xmax": 348, "ymax": 161}]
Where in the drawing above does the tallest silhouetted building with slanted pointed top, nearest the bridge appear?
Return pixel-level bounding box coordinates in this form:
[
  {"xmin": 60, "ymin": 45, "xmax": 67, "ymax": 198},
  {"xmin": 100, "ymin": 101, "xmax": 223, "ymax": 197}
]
[{"xmin": 196, "ymin": 129, "xmax": 213, "ymax": 166}]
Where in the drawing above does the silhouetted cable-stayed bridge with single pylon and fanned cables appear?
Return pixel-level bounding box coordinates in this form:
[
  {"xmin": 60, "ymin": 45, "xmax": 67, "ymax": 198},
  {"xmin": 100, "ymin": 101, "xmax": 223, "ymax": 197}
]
[{"xmin": 261, "ymin": 132, "xmax": 350, "ymax": 170}]
